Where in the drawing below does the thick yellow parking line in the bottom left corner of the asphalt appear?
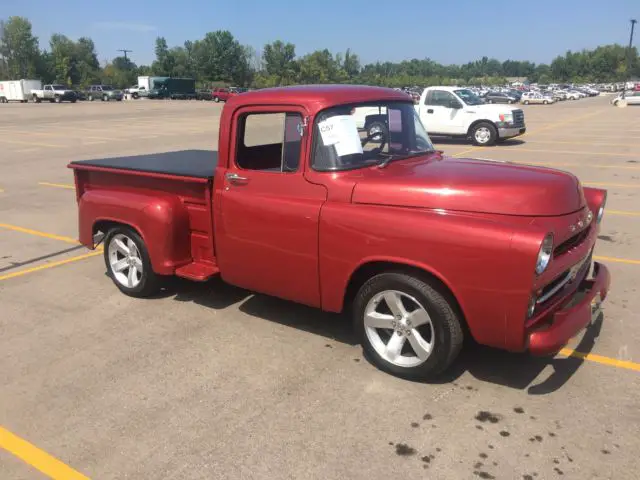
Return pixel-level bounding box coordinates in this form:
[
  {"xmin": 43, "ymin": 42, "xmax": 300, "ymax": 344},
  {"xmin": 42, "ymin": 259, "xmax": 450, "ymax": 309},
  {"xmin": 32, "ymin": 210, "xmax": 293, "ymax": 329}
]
[{"xmin": 0, "ymin": 427, "xmax": 89, "ymax": 480}]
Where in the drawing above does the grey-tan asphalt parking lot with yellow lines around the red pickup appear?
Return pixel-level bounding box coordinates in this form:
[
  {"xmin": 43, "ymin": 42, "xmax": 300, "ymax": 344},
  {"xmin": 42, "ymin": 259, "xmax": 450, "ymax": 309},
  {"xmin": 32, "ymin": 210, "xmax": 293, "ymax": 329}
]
[{"xmin": 0, "ymin": 96, "xmax": 640, "ymax": 480}]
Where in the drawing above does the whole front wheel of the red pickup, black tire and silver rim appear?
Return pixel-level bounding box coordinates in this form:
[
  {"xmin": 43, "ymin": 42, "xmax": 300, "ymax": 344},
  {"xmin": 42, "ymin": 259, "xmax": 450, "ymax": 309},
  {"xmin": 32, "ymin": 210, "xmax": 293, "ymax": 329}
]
[{"xmin": 353, "ymin": 273, "xmax": 463, "ymax": 380}]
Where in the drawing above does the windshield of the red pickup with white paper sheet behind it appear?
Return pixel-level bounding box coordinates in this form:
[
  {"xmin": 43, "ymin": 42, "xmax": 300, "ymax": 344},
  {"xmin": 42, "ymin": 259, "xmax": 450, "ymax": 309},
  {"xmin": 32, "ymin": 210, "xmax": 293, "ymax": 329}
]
[{"xmin": 311, "ymin": 101, "xmax": 434, "ymax": 171}]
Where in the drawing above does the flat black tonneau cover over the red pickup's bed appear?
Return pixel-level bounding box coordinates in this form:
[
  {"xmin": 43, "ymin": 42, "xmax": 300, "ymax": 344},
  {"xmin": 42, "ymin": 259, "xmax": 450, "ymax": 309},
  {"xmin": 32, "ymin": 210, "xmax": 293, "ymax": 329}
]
[{"xmin": 71, "ymin": 150, "xmax": 218, "ymax": 178}]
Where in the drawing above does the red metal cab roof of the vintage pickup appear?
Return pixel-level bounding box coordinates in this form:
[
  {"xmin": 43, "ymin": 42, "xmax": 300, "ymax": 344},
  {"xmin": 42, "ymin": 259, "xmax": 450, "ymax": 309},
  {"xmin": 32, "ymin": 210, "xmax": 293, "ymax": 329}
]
[{"xmin": 227, "ymin": 85, "xmax": 412, "ymax": 114}]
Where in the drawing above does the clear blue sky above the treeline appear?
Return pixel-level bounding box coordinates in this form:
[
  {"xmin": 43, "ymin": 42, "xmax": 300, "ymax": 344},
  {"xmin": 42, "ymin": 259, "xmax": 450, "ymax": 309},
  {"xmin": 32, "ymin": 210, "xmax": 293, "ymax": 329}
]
[{"xmin": 2, "ymin": 0, "xmax": 640, "ymax": 64}]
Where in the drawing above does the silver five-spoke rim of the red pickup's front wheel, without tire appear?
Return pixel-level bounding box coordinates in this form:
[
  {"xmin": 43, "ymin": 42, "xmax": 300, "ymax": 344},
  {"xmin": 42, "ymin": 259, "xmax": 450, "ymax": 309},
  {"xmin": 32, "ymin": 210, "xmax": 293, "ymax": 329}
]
[{"xmin": 364, "ymin": 290, "xmax": 435, "ymax": 367}]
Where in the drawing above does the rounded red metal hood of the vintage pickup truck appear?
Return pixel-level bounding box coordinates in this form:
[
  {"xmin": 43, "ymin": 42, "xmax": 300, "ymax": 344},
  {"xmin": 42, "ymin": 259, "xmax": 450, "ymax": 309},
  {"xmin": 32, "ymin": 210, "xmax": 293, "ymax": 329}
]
[{"xmin": 351, "ymin": 154, "xmax": 585, "ymax": 216}]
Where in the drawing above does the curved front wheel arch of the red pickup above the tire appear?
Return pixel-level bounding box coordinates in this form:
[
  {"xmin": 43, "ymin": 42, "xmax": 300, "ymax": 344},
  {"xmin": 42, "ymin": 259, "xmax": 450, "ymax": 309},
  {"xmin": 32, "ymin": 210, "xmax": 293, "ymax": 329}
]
[{"xmin": 342, "ymin": 259, "xmax": 471, "ymax": 335}]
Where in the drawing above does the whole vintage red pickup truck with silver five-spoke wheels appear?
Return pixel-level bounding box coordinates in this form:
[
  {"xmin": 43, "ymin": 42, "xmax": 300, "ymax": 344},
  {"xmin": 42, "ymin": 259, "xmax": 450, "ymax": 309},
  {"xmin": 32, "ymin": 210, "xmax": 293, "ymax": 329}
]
[{"xmin": 69, "ymin": 86, "xmax": 610, "ymax": 379}]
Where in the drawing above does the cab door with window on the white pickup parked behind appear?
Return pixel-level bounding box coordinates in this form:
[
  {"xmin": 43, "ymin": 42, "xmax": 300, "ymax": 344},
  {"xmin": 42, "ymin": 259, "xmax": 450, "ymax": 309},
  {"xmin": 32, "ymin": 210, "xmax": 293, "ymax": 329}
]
[{"xmin": 420, "ymin": 90, "xmax": 467, "ymax": 135}]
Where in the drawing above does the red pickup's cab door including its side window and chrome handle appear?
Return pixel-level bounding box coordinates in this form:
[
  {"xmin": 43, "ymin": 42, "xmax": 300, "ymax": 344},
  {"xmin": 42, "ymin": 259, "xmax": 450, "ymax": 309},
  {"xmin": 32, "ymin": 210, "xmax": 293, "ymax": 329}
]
[{"xmin": 214, "ymin": 106, "xmax": 326, "ymax": 307}]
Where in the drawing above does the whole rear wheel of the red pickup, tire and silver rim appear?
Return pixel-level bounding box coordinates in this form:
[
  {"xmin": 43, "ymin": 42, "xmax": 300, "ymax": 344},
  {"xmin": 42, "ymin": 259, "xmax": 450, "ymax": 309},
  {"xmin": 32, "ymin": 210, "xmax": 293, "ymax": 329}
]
[{"xmin": 104, "ymin": 226, "xmax": 160, "ymax": 298}]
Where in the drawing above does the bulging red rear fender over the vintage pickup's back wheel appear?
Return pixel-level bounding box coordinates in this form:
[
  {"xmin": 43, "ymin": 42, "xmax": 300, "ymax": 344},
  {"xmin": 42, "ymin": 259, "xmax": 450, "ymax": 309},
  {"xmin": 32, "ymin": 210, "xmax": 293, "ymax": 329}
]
[{"xmin": 78, "ymin": 190, "xmax": 192, "ymax": 275}]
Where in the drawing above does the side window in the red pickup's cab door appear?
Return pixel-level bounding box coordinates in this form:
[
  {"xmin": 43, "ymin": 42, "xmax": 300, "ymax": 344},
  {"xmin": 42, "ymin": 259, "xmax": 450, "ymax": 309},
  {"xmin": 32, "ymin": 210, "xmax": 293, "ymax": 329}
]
[{"xmin": 236, "ymin": 112, "xmax": 302, "ymax": 173}]
